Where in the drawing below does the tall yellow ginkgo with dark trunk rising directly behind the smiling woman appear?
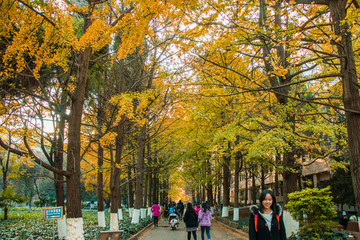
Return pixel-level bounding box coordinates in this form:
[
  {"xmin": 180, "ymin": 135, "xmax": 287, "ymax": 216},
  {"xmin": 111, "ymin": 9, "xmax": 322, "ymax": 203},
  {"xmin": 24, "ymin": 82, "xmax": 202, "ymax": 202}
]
[{"xmin": 165, "ymin": 1, "xmax": 352, "ymax": 210}]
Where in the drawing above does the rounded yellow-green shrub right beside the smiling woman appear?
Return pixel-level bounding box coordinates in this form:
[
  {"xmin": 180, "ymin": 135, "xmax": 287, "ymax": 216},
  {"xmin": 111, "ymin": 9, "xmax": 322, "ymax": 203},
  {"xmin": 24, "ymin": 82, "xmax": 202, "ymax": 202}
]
[{"xmin": 286, "ymin": 187, "xmax": 336, "ymax": 239}]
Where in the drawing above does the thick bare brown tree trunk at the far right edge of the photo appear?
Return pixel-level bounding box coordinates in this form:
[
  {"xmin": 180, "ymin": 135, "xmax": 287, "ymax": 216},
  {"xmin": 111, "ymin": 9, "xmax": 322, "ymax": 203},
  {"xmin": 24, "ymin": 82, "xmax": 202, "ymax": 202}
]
[{"xmin": 329, "ymin": 0, "xmax": 360, "ymax": 213}]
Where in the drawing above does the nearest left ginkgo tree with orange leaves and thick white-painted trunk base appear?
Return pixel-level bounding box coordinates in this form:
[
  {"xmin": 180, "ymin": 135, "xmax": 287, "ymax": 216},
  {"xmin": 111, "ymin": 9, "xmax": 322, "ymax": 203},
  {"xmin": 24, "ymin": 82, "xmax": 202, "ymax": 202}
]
[{"xmin": 1, "ymin": 1, "xmax": 200, "ymax": 239}]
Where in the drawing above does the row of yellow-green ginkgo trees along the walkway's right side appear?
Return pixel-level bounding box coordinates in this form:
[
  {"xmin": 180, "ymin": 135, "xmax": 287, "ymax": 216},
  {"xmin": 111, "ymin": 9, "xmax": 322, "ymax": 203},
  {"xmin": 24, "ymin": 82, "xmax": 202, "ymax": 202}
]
[{"xmin": 158, "ymin": 1, "xmax": 359, "ymax": 217}]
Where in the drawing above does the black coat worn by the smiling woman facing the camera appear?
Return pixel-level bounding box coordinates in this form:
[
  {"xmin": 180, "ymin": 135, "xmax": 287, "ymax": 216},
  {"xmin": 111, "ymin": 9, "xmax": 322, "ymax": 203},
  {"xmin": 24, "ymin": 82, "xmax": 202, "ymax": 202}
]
[{"xmin": 249, "ymin": 204, "xmax": 286, "ymax": 240}]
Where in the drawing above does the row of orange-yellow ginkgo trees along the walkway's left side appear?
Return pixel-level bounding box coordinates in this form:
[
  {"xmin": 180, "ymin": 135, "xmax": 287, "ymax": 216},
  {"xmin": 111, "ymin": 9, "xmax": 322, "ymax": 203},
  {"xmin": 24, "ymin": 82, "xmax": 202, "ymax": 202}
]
[{"xmin": 1, "ymin": 1, "xmax": 190, "ymax": 239}]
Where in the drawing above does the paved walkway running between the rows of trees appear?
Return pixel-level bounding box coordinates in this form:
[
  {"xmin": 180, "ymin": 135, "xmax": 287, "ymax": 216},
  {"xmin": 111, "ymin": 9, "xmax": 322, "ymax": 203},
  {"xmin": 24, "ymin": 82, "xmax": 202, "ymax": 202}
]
[{"xmin": 138, "ymin": 219, "xmax": 248, "ymax": 240}]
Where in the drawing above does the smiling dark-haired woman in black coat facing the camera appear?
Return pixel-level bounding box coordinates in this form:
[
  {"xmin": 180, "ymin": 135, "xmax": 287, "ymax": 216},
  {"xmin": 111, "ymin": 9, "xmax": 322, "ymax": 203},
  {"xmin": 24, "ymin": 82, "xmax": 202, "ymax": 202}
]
[{"xmin": 249, "ymin": 189, "xmax": 286, "ymax": 240}]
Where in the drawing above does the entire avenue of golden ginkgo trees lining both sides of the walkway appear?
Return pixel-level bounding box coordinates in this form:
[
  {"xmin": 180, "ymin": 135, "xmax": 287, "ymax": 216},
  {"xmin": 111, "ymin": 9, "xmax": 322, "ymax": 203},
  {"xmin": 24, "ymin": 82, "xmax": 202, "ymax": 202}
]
[{"xmin": 0, "ymin": 0, "xmax": 360, "ymax": 239}]
